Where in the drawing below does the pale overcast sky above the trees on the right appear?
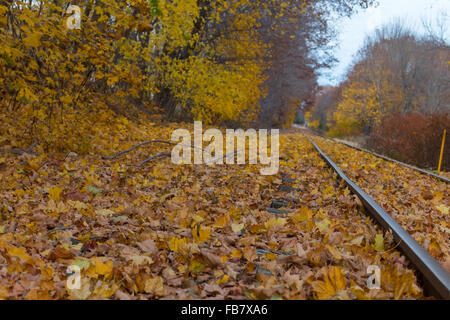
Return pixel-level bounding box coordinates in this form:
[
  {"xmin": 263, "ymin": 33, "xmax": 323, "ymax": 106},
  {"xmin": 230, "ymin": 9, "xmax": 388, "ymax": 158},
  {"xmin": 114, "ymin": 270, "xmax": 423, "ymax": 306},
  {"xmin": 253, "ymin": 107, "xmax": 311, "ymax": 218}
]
[{"xmin": 319, "ymin": 0, "xmax": 450, "ymax": 85}]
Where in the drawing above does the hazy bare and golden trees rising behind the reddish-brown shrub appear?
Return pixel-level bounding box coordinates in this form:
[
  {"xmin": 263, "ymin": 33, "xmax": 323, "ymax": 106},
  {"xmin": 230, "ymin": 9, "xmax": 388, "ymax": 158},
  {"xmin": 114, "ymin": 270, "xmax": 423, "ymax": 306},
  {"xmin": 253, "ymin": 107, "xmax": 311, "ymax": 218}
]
[{"xmin": 316, "ymin": 22, "xmax": 450, "ymax": 135}]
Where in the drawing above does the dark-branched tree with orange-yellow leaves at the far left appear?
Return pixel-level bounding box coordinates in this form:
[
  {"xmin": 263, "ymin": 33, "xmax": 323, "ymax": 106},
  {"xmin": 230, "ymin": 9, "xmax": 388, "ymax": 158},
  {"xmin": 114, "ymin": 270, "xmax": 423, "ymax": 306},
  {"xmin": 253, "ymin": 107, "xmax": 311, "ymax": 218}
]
[{"xmin": 0, "ymin": 0, "xmax": 159, "ymax": 151}]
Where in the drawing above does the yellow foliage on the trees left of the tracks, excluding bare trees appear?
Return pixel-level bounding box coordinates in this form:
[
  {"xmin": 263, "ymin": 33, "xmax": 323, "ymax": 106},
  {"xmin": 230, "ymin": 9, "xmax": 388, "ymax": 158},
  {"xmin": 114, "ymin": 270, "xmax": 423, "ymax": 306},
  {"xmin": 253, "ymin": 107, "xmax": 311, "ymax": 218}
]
[{"xmin": 0, "ymin": 0, "xmax": 276, "ymax": 149}]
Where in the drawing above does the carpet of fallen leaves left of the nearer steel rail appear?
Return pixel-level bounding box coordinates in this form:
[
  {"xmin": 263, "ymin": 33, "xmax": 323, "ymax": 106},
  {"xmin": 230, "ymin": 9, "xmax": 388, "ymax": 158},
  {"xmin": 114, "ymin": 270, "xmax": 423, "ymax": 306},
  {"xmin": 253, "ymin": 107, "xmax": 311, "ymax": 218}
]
[{"xmin": 0, "ymin": 127, "xmax": 428, "ymax": 299}]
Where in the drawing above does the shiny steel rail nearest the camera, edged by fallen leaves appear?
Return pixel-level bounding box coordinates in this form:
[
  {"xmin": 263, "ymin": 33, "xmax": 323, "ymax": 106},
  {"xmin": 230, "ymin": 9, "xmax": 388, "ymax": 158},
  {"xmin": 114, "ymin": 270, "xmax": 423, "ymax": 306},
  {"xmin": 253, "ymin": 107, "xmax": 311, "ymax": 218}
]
[{"xmin": 304, "ymin": 135, "xmax": 450, "ymax": 300}]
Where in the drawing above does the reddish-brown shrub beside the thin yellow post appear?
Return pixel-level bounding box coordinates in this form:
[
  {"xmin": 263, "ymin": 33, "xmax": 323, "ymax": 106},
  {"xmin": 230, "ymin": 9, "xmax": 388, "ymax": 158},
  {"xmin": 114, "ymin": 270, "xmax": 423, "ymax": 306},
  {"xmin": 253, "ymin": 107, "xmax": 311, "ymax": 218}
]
[{"xmin": 367, "ymin": 112, "xmax": 450, "ymax": 171}]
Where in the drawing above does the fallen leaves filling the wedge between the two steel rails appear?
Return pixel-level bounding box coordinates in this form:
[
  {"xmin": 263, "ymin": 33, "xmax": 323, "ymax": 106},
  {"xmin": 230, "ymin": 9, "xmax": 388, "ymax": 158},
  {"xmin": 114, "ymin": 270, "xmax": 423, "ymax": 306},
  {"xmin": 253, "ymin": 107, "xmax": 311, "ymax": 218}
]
[{"xmin": 313, "ymin": 137, "xmax": 450, "ymax": 266}]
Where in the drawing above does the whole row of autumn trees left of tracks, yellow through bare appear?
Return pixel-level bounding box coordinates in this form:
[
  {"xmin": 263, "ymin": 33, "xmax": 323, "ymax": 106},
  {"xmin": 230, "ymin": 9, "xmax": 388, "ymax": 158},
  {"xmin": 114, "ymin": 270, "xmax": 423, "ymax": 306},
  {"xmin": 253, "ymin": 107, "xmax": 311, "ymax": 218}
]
[{"xmin": 0, "ymin": 0, "xmax": 372, "ymax": 152}]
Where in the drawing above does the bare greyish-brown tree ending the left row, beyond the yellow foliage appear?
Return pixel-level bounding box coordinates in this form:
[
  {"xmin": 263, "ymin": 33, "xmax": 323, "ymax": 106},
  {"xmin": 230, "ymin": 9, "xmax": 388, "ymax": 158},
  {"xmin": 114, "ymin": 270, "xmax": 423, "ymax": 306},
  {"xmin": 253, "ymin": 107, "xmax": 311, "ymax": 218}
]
[{"xmin": 259, "ymin": 0, "xmax": 373, "ymax": 126}]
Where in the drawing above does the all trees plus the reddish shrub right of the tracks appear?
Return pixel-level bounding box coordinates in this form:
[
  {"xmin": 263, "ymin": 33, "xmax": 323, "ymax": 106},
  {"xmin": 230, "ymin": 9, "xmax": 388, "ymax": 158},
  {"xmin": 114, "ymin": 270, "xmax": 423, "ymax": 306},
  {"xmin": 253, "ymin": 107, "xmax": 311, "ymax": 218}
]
[{"xmin": 307, "ymin": 22, "xmax": 450, "ymax": 169}]
